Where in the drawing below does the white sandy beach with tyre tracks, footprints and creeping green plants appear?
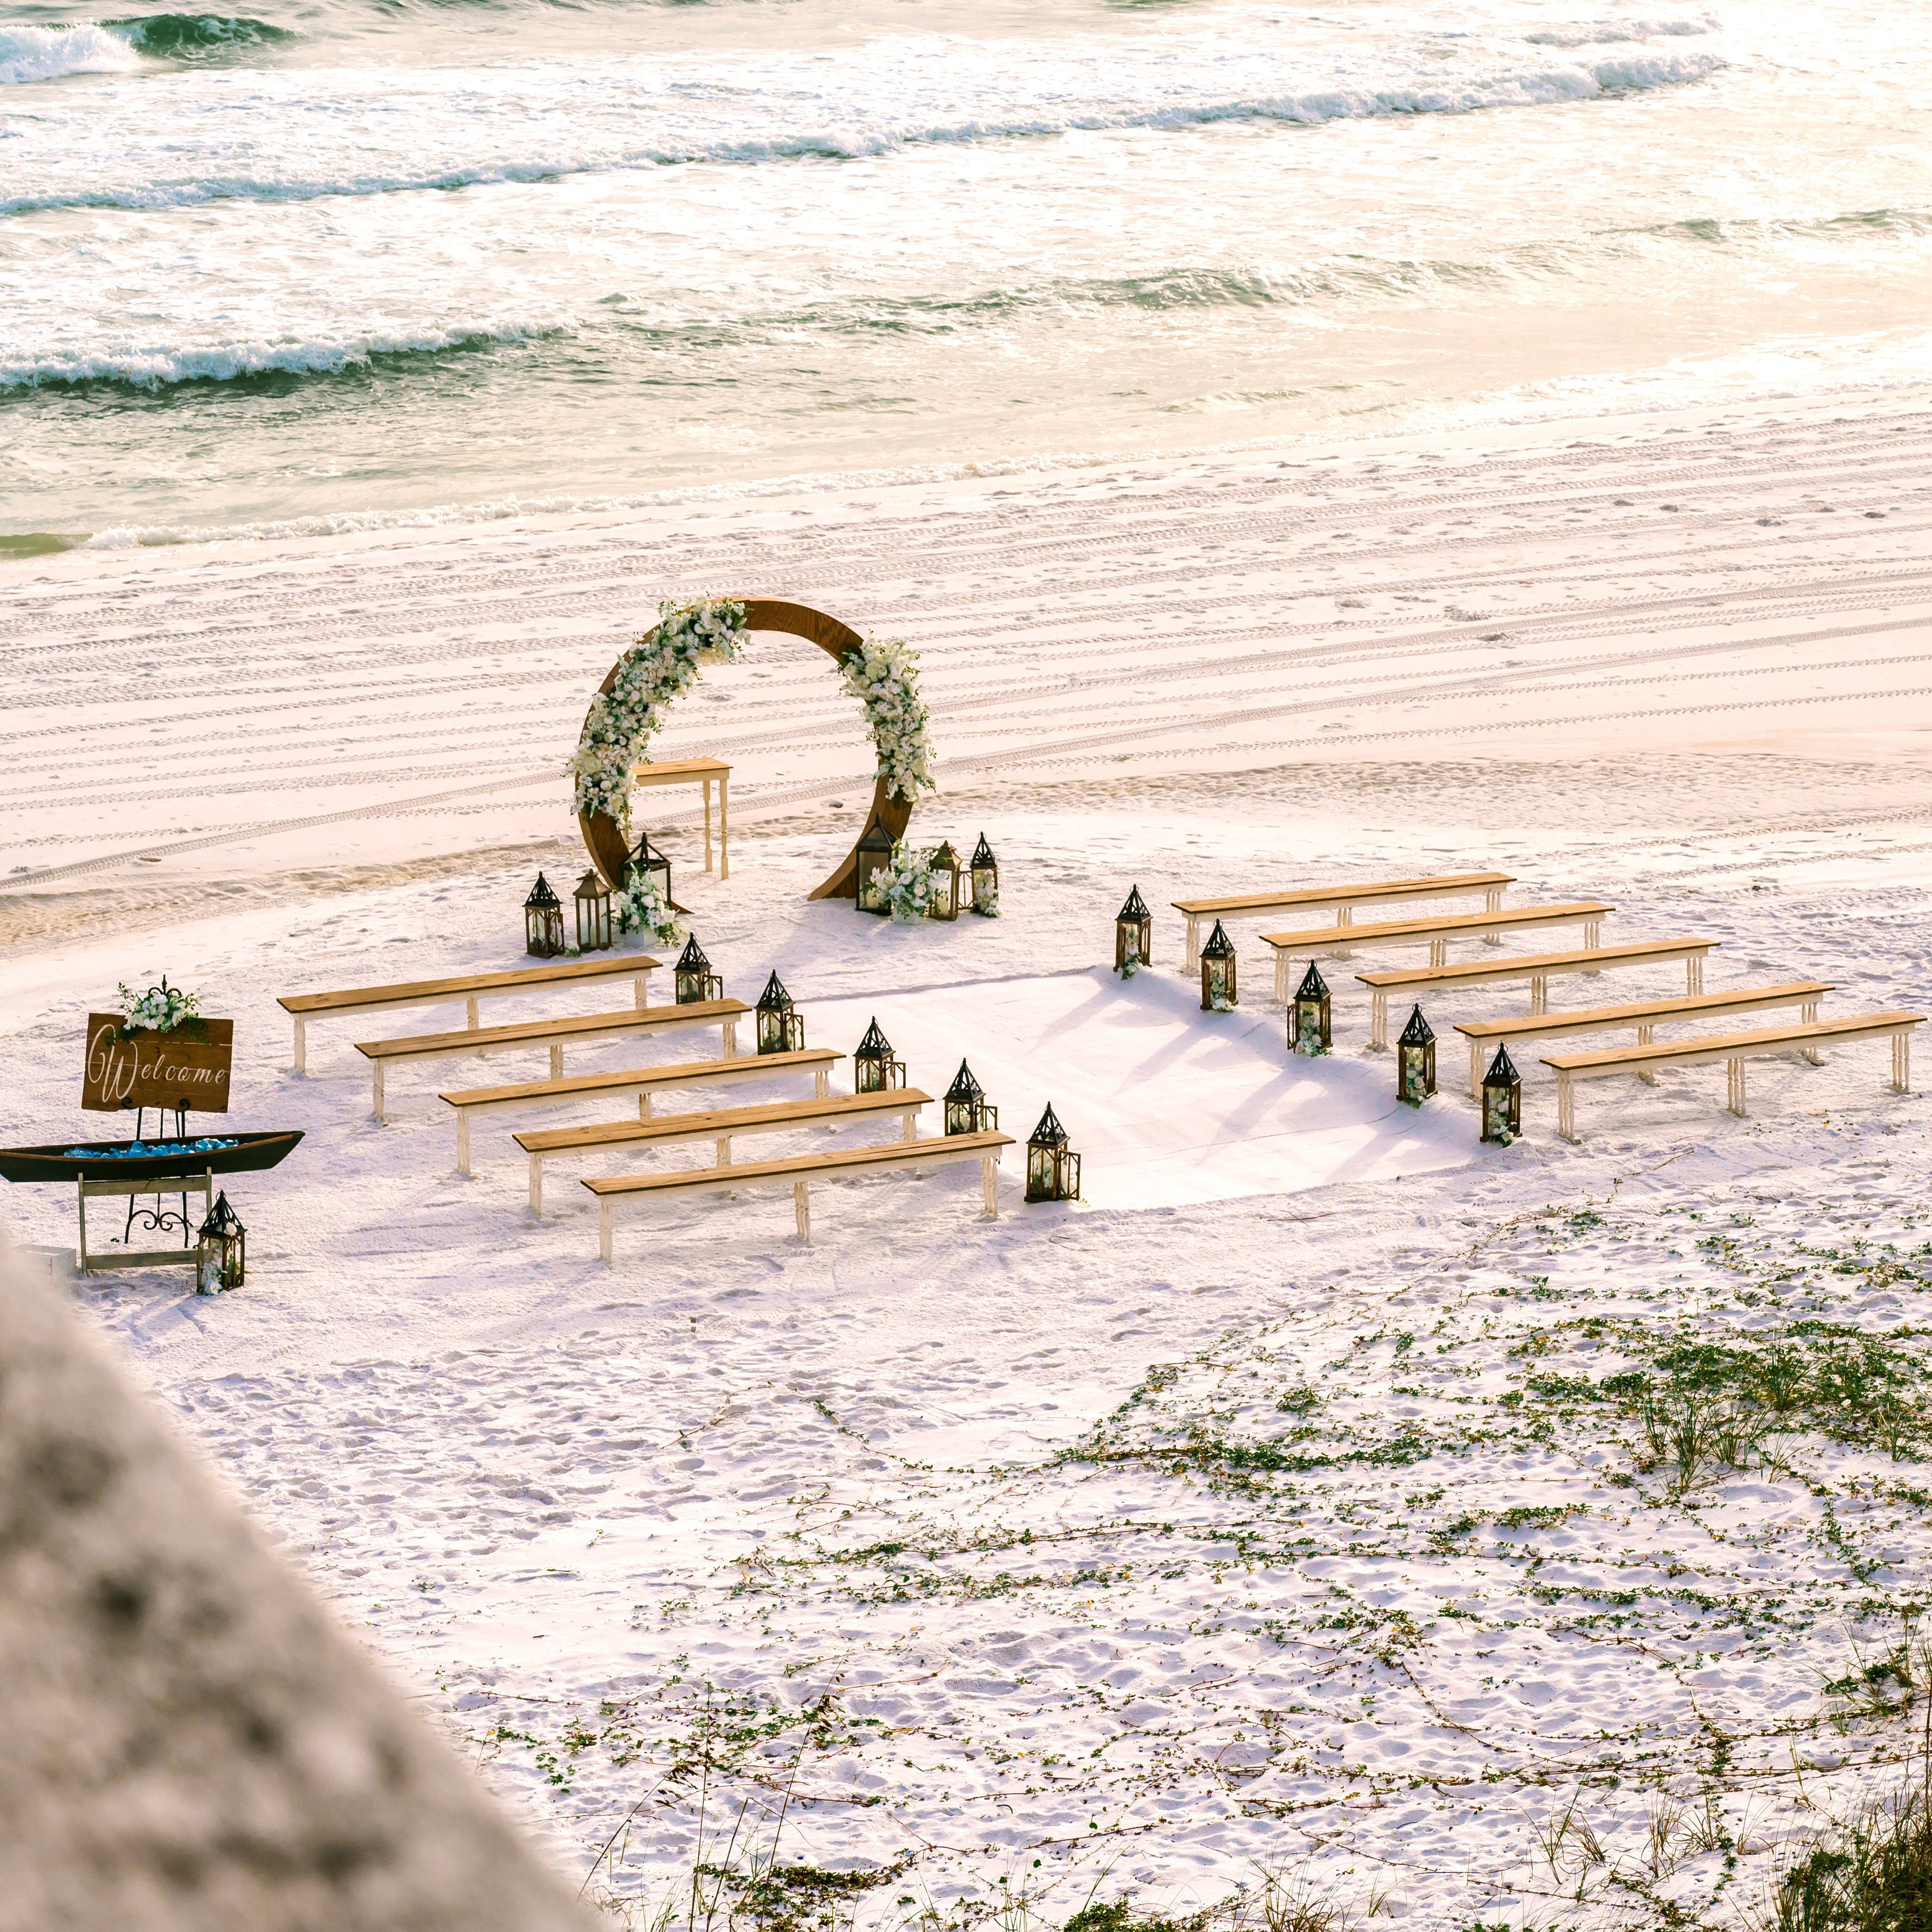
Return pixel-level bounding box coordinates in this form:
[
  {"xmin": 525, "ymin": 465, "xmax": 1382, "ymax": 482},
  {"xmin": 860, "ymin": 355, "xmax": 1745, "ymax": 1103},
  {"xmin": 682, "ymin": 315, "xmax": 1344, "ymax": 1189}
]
[{"xmin": 0, "ymin": 390, "xmax": 1932, "ymax": 1932}]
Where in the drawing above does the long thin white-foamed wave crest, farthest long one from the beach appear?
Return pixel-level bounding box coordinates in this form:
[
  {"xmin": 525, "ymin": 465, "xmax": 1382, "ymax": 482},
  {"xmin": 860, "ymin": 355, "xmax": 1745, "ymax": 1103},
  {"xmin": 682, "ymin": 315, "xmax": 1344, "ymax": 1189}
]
[{"xmin": 0, "ymin": 52, "xmax": 1723, "ymax": 215}]
